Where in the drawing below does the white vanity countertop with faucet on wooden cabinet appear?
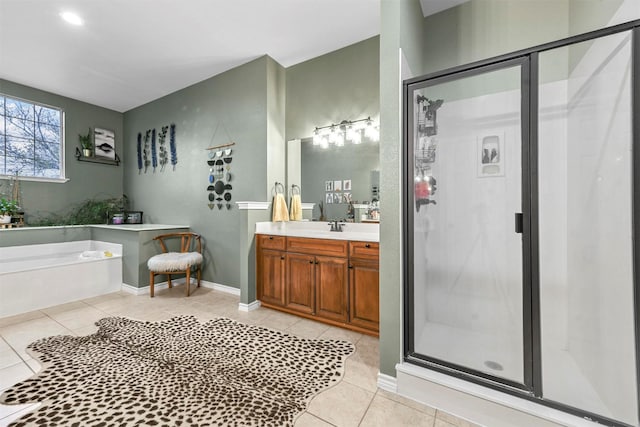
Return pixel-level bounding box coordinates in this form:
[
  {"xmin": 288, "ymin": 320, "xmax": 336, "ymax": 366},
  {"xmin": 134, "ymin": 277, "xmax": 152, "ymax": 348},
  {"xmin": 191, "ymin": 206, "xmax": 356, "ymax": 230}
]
[{"xmin": 256, "ymin": 221, "xmax": 380, "ymax": 242}]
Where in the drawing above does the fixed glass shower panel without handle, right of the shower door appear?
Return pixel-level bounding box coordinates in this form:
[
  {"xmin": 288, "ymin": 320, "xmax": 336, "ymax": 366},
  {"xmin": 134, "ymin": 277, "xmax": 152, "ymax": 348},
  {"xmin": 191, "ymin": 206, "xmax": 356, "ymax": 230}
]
[{"xmin": 538, "ymin": 31, "xmax": 638, "ymax": 425}]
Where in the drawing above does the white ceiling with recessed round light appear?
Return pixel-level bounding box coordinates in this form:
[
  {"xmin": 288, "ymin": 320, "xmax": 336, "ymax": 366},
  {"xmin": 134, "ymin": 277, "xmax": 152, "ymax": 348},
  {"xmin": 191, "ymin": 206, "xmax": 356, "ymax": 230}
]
[{"xmin": 0, "ymin": 0, "xmax": 464, "ymax": 112}]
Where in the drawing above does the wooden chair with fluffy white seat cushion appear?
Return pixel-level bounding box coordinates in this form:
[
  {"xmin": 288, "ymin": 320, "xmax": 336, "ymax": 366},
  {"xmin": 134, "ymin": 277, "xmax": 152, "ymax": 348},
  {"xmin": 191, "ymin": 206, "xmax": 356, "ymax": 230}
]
[{"xmin": 147, "ymin": 232, "xmax": 203, "ymax": 297}]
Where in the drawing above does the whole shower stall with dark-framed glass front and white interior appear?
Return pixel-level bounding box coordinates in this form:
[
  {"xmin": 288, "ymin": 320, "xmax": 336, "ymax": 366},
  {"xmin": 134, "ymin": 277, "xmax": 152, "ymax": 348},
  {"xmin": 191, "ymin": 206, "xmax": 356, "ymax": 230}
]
[{"xmin": 403, "ymin": 21, "xmax": 640, "ymax": 426}]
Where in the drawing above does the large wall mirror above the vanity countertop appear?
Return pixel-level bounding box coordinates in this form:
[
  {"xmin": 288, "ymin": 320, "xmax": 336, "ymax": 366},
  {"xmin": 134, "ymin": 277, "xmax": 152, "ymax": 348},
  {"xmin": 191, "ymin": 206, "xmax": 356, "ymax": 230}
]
[{"xmin": 287, "ymin": 138, "xmax": 380, "ymax": 222}]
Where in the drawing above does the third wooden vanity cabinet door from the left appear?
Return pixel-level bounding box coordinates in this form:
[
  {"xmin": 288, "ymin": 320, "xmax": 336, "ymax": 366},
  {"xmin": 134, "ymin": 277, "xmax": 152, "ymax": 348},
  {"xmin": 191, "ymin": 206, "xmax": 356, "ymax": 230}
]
[{"xmin": 315, "ymin": 256, "xmax": 349, "ymax": 322}]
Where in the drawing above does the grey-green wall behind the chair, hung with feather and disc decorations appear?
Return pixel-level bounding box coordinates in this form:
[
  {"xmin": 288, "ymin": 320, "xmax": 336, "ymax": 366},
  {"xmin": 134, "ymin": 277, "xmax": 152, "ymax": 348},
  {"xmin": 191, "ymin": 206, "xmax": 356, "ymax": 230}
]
[{"xmin": 124, "ymin": 56, "xmax": 276, "ymax": 287}]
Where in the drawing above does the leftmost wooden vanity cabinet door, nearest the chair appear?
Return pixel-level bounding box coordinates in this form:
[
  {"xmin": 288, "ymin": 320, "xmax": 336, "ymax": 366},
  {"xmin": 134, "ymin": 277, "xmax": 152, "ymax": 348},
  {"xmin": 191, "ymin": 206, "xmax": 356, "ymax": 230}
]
[{"xmin": 258, "ymin": 249, "xmax": 286, "ymax": 306}]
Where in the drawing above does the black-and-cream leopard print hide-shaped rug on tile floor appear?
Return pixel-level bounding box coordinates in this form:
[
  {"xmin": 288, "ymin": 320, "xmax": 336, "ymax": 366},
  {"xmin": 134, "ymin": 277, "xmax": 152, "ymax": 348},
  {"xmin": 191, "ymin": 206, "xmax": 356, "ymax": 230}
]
[{"xmin": 0, "ymin": 316, "xmax": 354, "ymax": 427}]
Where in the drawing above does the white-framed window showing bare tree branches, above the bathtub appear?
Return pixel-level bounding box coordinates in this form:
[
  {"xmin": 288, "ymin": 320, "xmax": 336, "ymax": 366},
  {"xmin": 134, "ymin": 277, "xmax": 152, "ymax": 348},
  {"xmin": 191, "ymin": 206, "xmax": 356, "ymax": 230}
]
[{"xmin": 0, "ymin": 94, "xmax": 64, "ymax": 179}]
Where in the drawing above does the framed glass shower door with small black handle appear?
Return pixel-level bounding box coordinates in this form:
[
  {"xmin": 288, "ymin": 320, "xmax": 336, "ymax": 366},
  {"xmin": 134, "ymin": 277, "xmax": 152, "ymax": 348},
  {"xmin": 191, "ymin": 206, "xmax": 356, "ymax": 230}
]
[{"xmin": 408, "ymin": 60, "xmax": 528, "ymax": 387}]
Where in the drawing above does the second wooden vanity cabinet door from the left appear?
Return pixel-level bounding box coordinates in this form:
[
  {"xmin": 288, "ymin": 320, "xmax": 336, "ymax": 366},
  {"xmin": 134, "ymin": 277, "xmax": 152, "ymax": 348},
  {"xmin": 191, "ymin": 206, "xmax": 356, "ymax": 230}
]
[{"xmin": 285, "ymin": 253, "xmax": 315, "ymax": 314}]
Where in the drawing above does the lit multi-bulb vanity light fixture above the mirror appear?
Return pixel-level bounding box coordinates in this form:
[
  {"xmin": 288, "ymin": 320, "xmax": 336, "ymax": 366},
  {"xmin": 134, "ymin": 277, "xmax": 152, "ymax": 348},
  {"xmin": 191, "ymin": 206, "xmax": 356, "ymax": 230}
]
[{"xmin": 313, "ymin": 117, "xmax": 380, "ymax": 148}]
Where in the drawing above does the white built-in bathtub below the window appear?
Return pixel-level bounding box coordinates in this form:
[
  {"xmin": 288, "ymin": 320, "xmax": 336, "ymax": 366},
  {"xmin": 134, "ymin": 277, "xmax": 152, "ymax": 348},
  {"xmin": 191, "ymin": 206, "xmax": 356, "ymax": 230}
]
[{"xmin": 0, "ymin": 240, "xmax": 122, "ymax": 317}]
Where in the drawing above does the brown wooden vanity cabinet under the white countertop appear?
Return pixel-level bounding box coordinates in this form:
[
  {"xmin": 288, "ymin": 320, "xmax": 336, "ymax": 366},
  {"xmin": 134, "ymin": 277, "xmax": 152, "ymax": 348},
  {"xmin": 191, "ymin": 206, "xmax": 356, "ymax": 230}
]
[{"xmin": 256, "ymin": 234, "xmax": 380, "ymax": 335}]
